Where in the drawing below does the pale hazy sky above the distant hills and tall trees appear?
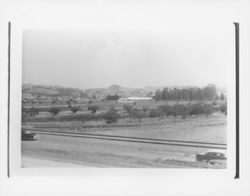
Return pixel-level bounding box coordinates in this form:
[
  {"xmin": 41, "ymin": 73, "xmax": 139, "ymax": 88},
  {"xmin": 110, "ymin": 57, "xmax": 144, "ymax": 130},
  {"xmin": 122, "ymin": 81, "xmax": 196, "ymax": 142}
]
[{"xmin": 22, "ymin": 23, "xmax": 234, "ymax": 88}]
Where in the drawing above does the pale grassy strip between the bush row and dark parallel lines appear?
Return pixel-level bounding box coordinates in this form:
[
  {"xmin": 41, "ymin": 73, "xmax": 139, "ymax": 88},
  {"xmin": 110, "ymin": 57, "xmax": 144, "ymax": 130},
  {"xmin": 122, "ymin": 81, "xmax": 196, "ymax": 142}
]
[{"xmin": 25, "ymin": 114, "xmax": 227, "ymax": 143}]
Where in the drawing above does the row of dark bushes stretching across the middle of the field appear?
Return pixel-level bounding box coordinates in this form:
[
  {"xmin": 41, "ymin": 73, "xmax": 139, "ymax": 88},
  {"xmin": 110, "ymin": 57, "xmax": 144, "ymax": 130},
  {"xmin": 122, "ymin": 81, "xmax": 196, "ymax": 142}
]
[{"xmin": 22, "ymin": 102, "xmax": 227, "ymax": 123}]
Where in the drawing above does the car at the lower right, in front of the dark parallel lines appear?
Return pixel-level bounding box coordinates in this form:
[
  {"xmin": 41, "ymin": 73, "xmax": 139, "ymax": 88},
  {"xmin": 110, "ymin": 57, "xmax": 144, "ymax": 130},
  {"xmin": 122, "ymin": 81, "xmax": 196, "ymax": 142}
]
[{"xmin": 196, "ymin": 149, "xmax": 227, "ymax": 163}]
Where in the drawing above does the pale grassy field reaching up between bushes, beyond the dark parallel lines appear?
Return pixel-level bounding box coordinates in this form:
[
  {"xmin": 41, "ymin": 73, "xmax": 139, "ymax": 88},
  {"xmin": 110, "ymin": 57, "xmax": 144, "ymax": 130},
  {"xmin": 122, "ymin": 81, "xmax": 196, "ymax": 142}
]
[{"xmin": 23, "ymin": 101, "xmax": 227, "ymax": 143}]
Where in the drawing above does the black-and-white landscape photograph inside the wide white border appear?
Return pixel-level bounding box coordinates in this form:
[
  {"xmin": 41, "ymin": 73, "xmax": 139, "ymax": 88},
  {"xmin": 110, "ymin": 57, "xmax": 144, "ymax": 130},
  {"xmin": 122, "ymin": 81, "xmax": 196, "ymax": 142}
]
[{"xmin": 21, "ymin": 23, "xmax": 230, "ymax": 169}]
